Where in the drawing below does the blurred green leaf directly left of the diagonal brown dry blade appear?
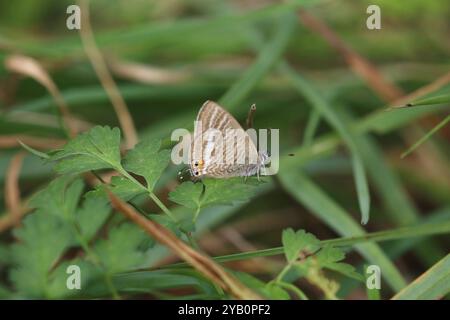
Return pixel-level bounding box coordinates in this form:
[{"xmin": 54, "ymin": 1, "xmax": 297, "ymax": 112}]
[{"xmin": 93, "ymin": 223, "xmax": 145, "ymax": 274}]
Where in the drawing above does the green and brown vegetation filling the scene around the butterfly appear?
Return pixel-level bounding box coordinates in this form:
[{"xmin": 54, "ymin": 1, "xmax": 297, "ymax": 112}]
[{"xmin": 0, "ymin": 0, "xmax": 450, "ymax": 300}]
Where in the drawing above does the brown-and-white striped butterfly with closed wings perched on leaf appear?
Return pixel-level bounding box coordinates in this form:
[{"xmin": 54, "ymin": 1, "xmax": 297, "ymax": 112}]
[{"xmin": 185, "ymin": 101, "xmax": 269, "ymax": 179}]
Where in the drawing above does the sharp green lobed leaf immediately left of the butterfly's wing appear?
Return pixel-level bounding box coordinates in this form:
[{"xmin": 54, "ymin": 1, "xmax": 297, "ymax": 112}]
[{"xmin": 124, "ymin": 139, "xmax": 170, "ymax": 191}]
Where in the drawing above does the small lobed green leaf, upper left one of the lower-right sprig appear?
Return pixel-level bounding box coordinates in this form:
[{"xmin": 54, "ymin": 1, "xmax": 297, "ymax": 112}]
[{"xmin": 282, "ymin": 228, "xmax": 320, "ymax": 263}]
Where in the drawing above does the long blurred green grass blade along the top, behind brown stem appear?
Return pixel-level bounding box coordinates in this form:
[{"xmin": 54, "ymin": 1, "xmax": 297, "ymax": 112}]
[{"xmin": 0, "ymin": 1, "xmax": 304, "ymax": 58}]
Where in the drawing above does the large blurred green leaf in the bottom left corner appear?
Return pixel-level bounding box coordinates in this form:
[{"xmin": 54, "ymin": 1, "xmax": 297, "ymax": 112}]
[{"xmin": 10, "ymin": 209, "xmax": 73, "ymax": 298}]
